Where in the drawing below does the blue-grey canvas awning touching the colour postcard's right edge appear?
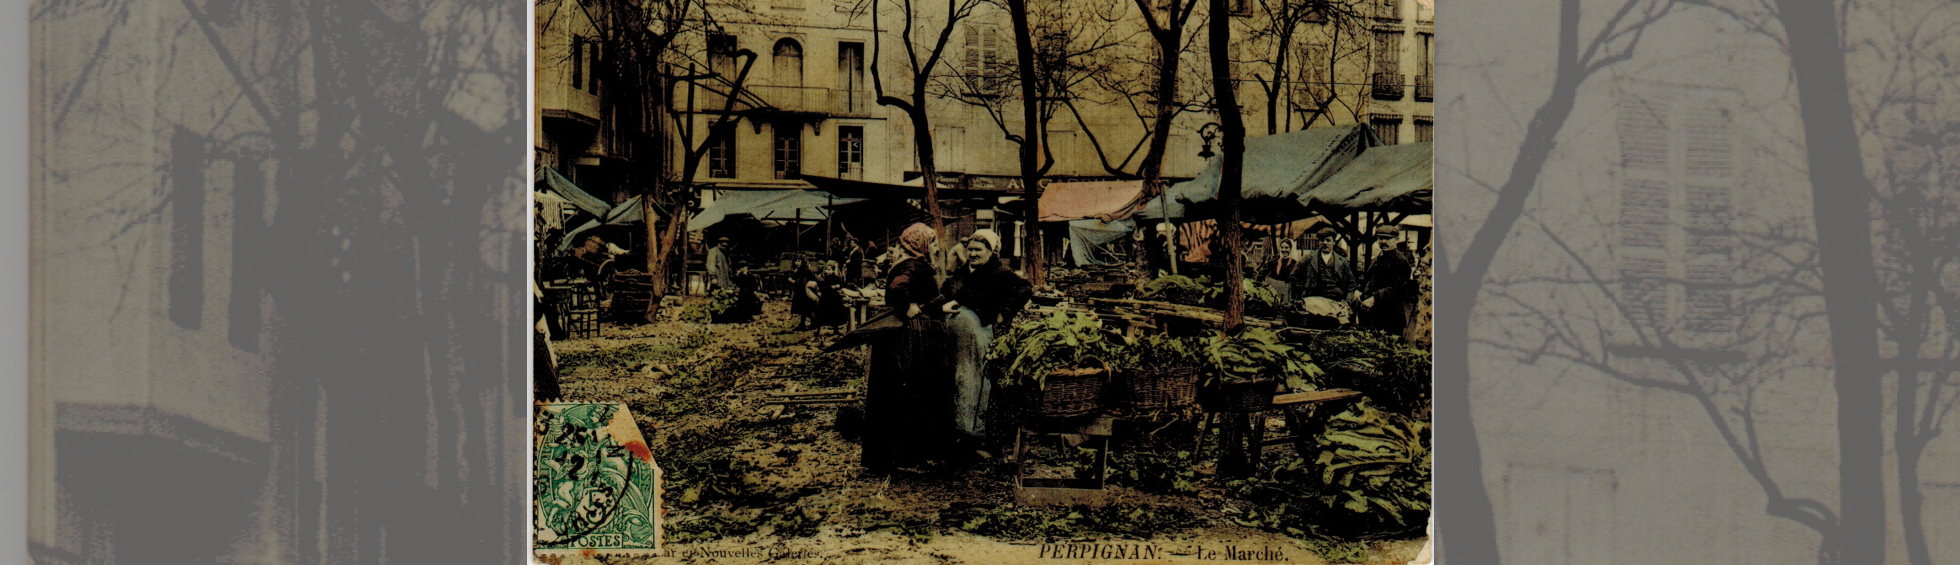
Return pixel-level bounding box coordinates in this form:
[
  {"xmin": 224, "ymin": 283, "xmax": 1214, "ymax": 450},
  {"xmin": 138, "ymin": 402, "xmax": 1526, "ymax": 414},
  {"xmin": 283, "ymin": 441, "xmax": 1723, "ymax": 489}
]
[{"xmin": 1299, "ymin": 141, "xmax": 1437, "ymax": 214}]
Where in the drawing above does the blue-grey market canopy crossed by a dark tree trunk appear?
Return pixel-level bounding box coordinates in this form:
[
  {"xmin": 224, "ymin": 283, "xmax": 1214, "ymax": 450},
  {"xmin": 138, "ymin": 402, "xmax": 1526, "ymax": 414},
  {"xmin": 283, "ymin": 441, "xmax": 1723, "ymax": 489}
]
[{"xmin": 1137, "ymin": 124, "xmax": 1380, "ymax": 224}]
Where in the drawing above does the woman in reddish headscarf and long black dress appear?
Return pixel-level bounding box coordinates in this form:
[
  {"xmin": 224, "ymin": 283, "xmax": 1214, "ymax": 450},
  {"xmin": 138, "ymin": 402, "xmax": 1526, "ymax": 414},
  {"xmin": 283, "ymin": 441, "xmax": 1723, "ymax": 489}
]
[{"xmin": 862, "ymin": 224, "xmax": 953, "ymax": 473}]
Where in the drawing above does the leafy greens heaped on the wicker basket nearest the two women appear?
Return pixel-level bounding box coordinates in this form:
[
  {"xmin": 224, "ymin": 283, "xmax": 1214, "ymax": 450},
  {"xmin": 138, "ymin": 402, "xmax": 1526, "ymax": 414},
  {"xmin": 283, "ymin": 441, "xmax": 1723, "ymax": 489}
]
[{"xmin": 988, "ymin": 310, "xmax": 1123, "ymax": 388}]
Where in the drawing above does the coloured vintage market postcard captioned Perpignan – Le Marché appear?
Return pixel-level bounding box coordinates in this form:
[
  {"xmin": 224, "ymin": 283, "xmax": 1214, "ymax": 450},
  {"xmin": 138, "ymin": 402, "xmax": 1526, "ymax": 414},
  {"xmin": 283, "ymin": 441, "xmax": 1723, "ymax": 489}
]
[{"xmin": 527, "ymin": 0, "xmax": 1435, "ymax": 565}]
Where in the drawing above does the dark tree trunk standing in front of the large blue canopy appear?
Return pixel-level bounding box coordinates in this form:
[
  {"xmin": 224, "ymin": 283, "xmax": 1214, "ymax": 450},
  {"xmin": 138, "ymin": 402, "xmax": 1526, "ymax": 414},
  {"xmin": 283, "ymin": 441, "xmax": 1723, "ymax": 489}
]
[{"xmin": 1209, "ymin": 0, "xmax": 1245, "ymax": 328}]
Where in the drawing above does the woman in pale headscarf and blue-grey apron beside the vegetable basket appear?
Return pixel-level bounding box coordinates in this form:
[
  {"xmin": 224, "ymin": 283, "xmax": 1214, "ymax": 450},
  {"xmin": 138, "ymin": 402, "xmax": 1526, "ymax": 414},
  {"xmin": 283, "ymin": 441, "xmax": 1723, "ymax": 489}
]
[{"xmin": 941, "ymin": 230, "xmax": 1035, "ymax": 441}]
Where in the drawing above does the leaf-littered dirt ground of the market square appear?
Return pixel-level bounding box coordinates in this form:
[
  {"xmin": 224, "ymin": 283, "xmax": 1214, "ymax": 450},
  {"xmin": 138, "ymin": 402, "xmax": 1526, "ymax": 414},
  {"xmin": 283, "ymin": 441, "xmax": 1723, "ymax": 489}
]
[{"xmin": 543, "ymin": 298, "xmax": 1427, "ymax": 563}]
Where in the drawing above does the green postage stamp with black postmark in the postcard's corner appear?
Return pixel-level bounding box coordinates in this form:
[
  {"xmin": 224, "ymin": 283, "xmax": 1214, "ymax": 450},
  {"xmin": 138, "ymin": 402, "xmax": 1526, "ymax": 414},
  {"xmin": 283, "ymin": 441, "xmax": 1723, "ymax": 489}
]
[{"xmin": 531, "ymin": 404, "xmax": 661, "ymax": 555}]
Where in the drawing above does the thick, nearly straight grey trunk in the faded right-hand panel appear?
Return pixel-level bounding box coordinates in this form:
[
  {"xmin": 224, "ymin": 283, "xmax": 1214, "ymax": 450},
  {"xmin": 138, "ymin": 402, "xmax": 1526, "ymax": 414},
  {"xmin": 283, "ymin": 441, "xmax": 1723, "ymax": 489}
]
[{"xmin": 1776, "ymin": 0, "xmax": 1903, "ymax": 563}]
